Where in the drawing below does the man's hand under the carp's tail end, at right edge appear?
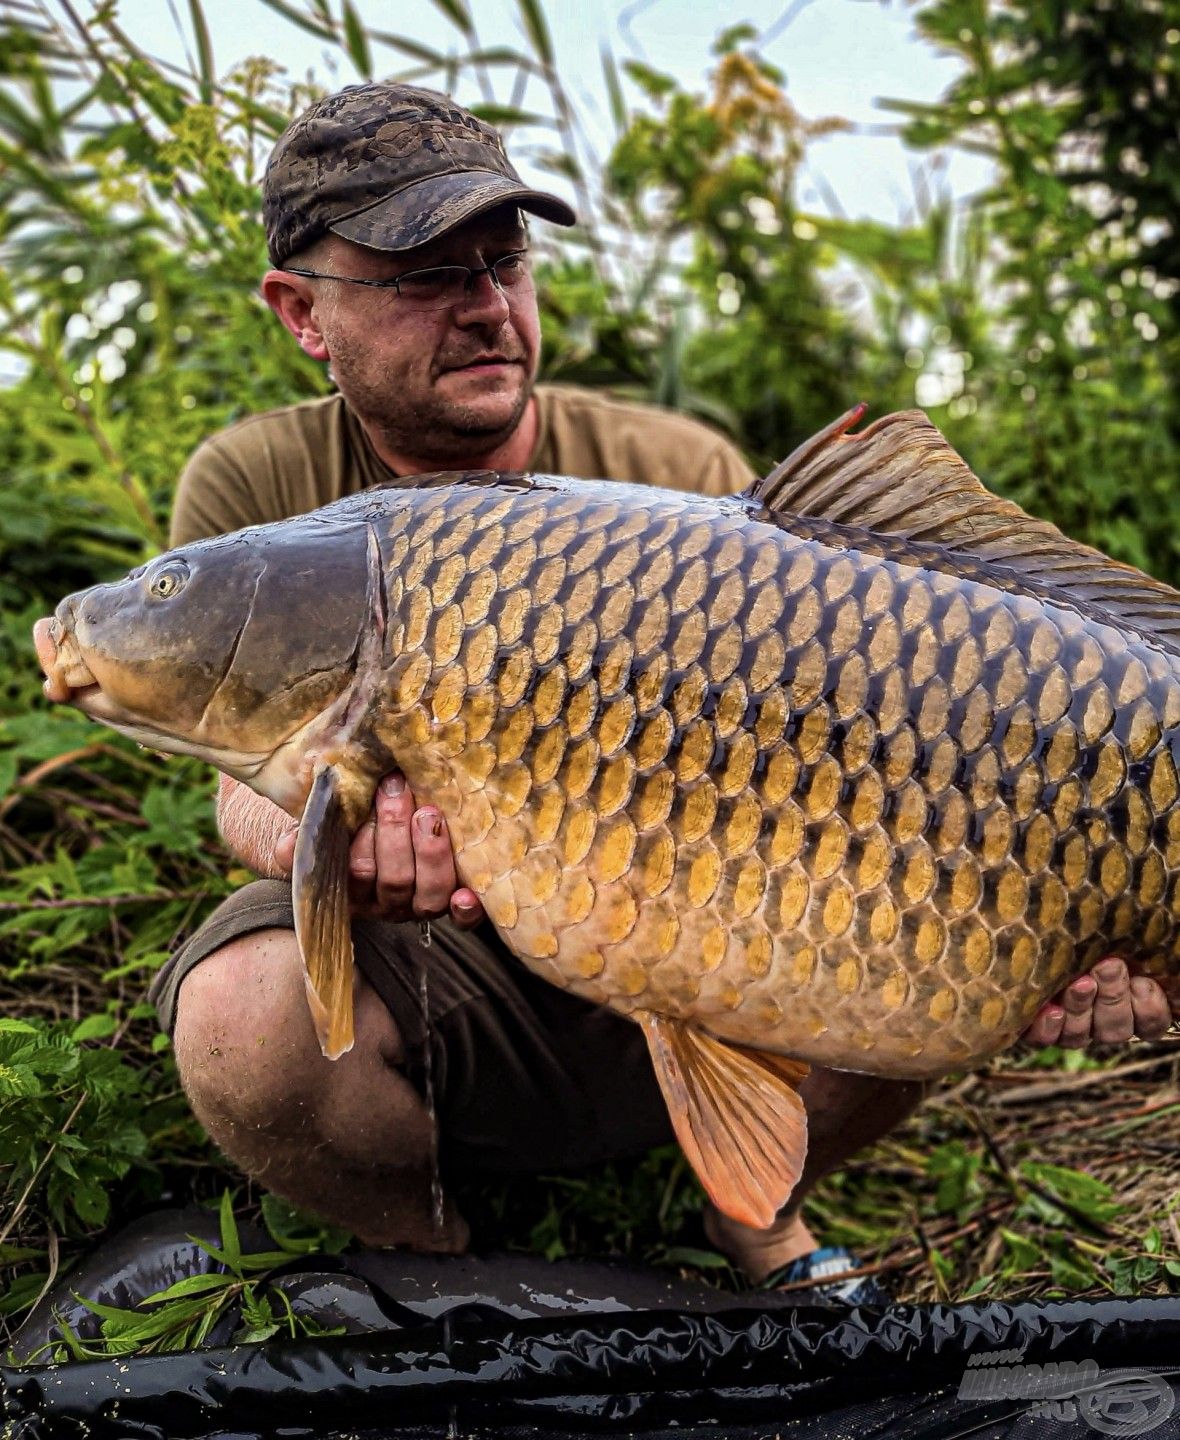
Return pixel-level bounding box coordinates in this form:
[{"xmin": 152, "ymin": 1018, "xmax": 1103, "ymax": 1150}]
[{"xmin": 1020, "ymin": 956, "xmax": 1171, "ymax": 1050}]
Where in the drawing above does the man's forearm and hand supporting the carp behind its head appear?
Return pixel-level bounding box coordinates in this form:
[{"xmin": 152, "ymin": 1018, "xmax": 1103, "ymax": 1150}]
[{"xmin": 218, "ymin": 775, "xmax": 484, "ymax": 929}]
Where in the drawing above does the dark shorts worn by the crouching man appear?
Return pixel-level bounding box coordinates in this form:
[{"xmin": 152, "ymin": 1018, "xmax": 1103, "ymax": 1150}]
[{"xmin": 150, "ymin": 880, "xmax": 673, "ymax": 1174}]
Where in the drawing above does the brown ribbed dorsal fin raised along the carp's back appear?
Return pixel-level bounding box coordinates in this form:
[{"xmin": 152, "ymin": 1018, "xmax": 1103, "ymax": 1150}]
[{"xmin": 748, "ymin": 405, "xmax": 1180, "ymax": 649}]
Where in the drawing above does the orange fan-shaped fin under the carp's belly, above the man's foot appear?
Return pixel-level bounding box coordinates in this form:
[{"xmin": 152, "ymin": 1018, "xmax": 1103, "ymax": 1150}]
[{"xmin": 635, "ymin": 1011, "xmax": 808, "ymax": 1230}]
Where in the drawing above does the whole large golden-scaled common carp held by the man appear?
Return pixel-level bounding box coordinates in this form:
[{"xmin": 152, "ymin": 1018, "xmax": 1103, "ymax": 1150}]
[{"xmin": 36, "ymin": 412, "xmax": 1180, "ymax": 1225}]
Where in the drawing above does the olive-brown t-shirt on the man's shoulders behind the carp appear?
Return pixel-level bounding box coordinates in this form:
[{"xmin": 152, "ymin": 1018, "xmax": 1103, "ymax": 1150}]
[{"xmin": 170, "ymin": 384, "xmax": 754, "ymax": 546}]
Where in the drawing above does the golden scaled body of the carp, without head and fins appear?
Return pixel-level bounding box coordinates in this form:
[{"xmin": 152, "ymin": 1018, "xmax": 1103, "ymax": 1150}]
[{"xmin": 382, "ymin": 487, "xmax": 1180, "ymax": 1076}]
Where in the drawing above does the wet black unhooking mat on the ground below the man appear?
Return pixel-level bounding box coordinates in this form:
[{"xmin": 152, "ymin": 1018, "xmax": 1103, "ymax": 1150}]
[{"xmin": 0, "ymin": 1211, "xmax": 1180, "ymax": 1440}]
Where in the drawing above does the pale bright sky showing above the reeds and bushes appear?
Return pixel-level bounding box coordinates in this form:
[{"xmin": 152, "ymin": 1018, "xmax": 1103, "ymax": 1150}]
[{"xmin": 110, "ymin": 0, "xmax": 987, "ymax": 223}]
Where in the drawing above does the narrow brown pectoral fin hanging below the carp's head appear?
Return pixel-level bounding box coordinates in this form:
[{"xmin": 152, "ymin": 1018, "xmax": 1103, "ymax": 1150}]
[{"xmin": 291, "ymin": 765, "xmax": 353, "ymax": 1060}]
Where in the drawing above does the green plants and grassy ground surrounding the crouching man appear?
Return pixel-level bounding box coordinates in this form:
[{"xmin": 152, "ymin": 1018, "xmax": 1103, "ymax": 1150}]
[{"xmin": 0, "ymin": 0, "xmax": 1180, "ymax": 1351}]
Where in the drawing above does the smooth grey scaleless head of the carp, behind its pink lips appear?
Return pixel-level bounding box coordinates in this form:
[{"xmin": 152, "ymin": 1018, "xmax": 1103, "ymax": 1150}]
[{"xmin": 56, "ymin": 517, "xmax": 370, "ymax": 763}]
